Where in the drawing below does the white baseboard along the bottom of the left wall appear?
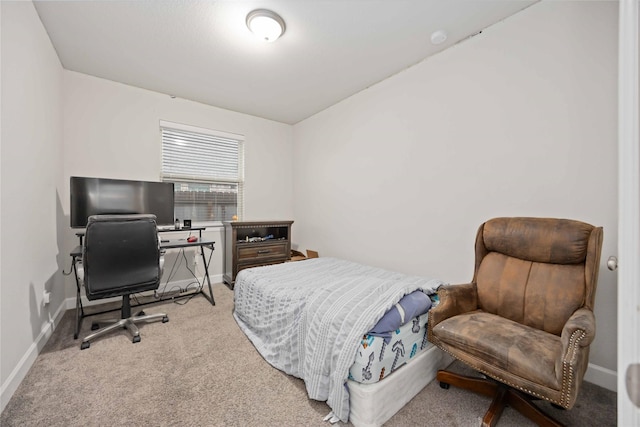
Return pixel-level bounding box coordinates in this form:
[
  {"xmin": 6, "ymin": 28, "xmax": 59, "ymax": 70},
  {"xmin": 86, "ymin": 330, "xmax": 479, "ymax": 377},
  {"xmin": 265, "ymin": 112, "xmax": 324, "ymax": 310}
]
[{"xmin": 0, "ymin": 300, "xmax": 67, "ymax": 412}]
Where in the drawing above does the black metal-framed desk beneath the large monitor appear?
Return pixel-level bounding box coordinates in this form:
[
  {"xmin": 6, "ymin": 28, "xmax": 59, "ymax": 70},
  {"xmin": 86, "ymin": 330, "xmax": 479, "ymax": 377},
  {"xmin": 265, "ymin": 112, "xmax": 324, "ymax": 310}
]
[{"xmin": 69, "ymin": 239, "xmax": 216, "ymax": 339}]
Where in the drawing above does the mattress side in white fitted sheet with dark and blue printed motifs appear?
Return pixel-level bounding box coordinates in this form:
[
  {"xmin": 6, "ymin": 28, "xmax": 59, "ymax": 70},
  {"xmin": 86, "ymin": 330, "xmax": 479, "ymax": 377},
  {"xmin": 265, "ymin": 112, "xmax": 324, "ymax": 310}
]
[{"xmin": 349, "ymin": 313, "xmax": 433, "ymax": 384}]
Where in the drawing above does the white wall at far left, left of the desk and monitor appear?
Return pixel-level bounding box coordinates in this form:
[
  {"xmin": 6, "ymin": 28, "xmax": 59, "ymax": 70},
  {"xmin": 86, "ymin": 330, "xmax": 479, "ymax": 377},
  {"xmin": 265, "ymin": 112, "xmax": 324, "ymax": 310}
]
[{"xmin": 0, "ymin": 2, "xmax": 65, "ymax": 408}]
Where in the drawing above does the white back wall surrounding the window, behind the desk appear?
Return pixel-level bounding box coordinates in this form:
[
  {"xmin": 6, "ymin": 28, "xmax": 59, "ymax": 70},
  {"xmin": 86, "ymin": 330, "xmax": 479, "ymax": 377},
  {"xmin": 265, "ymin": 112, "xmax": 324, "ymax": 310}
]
[{"xmin": 62, "ymin": 70, "xmax": 293, "ymax": 298}]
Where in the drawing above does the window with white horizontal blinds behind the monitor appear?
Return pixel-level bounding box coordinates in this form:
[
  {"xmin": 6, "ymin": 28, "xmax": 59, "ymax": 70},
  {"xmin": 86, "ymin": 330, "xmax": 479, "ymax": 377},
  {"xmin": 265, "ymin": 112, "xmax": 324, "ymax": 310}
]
[{"xmin": 160, "ymin": 121, "xmax": 244, "ymax": 223}]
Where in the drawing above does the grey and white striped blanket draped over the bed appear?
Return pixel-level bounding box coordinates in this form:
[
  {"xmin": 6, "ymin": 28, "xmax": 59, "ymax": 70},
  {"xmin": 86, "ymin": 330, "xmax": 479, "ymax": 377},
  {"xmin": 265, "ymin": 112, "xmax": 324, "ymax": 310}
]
[{"xmin": 233, "ymin": 258, "xmax": 444, "ymax": 422}]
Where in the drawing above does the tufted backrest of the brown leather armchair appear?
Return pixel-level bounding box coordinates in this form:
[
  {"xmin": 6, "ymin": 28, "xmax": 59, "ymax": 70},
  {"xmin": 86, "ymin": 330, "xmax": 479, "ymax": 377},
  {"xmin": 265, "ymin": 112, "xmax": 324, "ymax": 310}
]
[{"xmin": 473, "ymin": 218, "xmax": 602, "ymax": 335}]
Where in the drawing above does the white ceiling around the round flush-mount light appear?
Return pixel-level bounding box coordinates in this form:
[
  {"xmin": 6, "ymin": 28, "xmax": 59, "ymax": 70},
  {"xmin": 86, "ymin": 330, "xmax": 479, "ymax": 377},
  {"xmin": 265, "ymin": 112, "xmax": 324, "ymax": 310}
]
[{"xmin": 34, "ymin": 0, "xmax": 538, "ymax": 124}]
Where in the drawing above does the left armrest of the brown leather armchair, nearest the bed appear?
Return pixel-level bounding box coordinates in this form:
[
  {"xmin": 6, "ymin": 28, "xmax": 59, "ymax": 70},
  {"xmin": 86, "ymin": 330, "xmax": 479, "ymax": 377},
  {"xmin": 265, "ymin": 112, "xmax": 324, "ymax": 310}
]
[{"xmin": 429, "ymin": 283, "xmax": 478, "ymax": 329}]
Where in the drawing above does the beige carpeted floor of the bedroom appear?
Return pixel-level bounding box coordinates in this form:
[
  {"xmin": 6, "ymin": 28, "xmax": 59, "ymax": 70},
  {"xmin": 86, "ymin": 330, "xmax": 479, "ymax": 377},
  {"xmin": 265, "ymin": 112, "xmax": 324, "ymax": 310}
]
[{"xmin": 0, "ymin": 284, "xmax": 616, "ymax": 427}]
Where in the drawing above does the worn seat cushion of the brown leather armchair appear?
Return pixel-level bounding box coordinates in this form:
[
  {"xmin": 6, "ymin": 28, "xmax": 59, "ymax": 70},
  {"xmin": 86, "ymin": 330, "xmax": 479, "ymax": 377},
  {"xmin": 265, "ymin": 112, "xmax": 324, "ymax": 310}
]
[{"xmin": 433, "ymin": 310, "xmax": 562, "ymax": 390}]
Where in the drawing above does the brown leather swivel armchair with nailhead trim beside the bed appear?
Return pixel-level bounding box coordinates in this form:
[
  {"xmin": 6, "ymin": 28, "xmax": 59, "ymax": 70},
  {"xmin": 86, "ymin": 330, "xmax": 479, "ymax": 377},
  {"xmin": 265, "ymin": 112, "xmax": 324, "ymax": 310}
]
[{"xmin": 428, "ymin": 218, "xmax": 602, "ymax": 425}]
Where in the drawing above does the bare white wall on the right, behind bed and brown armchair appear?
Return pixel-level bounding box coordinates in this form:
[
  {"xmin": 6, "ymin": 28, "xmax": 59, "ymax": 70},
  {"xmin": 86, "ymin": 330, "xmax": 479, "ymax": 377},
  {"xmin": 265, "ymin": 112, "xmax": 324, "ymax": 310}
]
[{"xmin": 294, "ymin": 1, "xmax": 617, "ymax": 389}]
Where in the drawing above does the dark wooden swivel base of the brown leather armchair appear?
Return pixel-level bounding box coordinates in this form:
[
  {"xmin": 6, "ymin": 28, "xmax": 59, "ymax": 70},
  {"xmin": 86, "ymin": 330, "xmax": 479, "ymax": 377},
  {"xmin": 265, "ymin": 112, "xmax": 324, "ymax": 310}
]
[{"xmin": 436, "ymin": 371, "xmax": 563, "ymax": 427}]
